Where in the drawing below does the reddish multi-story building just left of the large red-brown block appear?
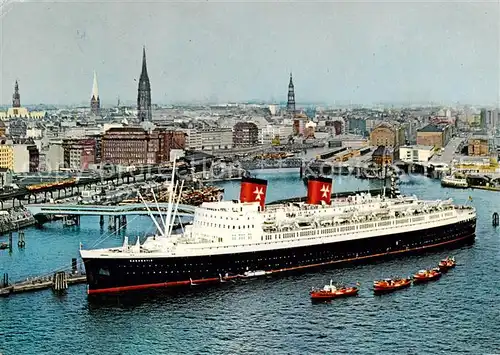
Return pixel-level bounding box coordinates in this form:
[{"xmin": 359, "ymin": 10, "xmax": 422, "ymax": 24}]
[{"xmin": 62, "ymin": 139, "xmax": 96, "ymax": 171}]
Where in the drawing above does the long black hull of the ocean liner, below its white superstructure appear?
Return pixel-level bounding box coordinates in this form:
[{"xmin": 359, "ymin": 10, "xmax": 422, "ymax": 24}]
[{"xmin": 83, "ymin": 218, "xmax": 476, "ymax": 294}]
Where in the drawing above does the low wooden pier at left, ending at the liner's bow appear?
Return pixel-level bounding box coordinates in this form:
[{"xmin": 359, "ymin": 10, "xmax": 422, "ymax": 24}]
[{"xmin": 0, "ymin": 272, "xmax": 87, "ymax": 297}]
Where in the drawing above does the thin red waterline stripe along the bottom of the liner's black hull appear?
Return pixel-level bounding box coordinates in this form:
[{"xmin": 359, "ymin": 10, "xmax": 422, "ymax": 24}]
[{"xmin": 88, "ymin": 235, "xmax": 470, "ymax": 295}]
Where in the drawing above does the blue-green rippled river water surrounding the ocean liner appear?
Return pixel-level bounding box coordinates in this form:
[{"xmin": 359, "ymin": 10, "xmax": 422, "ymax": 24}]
[{"xmin": 0, "ymin": 170, "xmax": 500, "ymax": 354}]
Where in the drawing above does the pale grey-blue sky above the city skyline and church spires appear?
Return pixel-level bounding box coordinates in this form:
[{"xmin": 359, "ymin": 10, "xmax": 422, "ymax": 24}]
[{"xmin": 0, "ymin": 0, "xmax": 500, "ymax": 106}]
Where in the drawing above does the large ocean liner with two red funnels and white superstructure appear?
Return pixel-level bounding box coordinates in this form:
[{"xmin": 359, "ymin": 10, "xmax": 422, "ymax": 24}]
[{"xmin": 80, "ymin": 168, "xmax": 476, "ymax": 294}]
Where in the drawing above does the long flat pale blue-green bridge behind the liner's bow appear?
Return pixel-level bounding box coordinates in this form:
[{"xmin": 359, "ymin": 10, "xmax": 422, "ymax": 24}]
[{"xmin": 26, "ymin": 203, "xmax": 195, "ymax": 218}]
